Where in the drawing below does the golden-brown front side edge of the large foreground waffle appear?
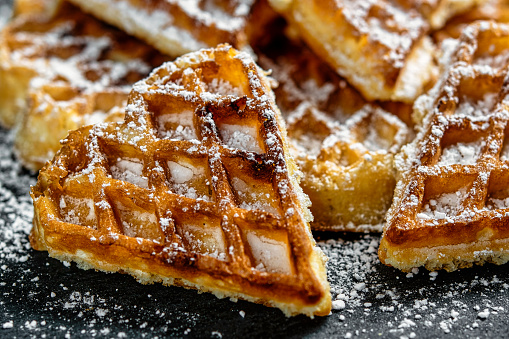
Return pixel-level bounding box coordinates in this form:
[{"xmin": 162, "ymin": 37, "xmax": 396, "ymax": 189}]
[{"xmin": 30, "ymin": 198, "xmax": 330, "ymax": 317}]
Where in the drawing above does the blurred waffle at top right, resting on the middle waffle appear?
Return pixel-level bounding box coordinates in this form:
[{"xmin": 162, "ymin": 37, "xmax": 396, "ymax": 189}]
[{"xmin": 269, "ymin": 0, "xmax": 433, "ymax": 102}]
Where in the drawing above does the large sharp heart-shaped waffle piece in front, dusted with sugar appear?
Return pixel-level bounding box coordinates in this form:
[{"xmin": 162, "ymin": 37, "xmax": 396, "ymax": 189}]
[{"xmin": 31, "ymin": 45, "xmax": 331, "ymax": 316}]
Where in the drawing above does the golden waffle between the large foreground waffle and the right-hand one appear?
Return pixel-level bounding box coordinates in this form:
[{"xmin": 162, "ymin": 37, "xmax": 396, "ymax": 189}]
[{"xmin": 259, "ymin": 38, "xmax": 409, "ymax": 232}]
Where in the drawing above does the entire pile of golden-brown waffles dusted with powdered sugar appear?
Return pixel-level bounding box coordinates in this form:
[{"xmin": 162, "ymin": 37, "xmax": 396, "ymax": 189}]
[{"xmin": 4, "ymin": 0, "xmax": 509, "ymax": 316}]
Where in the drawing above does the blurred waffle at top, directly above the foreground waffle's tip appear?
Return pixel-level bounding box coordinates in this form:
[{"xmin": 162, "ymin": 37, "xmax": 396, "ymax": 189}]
[{"xmin": 66, "ymin": 0, "xmax": 254, "ymax": 57}]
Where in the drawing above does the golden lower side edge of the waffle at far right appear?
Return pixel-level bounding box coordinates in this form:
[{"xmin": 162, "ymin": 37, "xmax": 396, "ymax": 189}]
[{"xmin": 379, "ymin": 238, "xmax": 509, "ymax": 272}]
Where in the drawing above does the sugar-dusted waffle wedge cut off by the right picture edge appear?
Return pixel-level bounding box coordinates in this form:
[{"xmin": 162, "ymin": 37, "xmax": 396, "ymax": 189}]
[{"xmin": 379, "ymin": 21, "xmax": 509, "ymax": 271}]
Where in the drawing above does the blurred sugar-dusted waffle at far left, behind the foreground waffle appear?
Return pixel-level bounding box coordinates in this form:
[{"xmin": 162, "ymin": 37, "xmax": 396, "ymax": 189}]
[{"xmin": 0, "ymin": 0, "xmax": 165, "ymax": 170}]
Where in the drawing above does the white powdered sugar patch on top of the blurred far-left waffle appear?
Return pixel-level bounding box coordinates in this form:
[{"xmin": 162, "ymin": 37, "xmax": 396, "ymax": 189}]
[{"xmin": 10, "ymin": 20, "xmax": 150, "ymax": 93}]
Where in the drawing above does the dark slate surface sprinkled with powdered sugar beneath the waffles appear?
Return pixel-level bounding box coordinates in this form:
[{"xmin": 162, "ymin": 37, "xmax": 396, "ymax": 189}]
[{"xmin": 0, "ymin": 1, "xmax": 509, "ymax": 338}]
